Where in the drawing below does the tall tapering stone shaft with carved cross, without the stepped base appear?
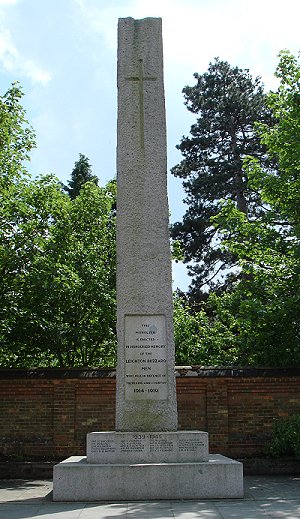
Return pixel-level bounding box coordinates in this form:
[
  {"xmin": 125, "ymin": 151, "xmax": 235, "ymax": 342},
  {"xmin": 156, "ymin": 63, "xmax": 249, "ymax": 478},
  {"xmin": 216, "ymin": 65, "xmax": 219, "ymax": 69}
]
[{"xmin": 116, "ymin": 18, "xmax": 177, "ymax": 431}]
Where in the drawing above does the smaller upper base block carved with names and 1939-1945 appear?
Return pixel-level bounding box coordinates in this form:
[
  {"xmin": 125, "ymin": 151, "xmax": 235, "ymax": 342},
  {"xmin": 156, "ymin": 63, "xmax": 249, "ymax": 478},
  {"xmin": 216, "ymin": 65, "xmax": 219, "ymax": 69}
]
[{"xmin": 87, "ymin": 431, "xmax": 208, "ymax": 464}]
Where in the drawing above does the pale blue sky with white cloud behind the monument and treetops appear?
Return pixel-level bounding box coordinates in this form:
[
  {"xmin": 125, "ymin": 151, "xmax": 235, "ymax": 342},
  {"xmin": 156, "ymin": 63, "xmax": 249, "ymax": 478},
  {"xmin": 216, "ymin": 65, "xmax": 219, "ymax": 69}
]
[{"xmin": 0, "ymin": 0, "xmax": 300, "ymax": 290}]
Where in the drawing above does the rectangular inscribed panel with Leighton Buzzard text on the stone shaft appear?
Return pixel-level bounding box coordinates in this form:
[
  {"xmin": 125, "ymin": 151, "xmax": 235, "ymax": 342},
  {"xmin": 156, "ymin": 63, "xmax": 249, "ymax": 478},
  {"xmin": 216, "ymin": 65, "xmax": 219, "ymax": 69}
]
[{"xmin": 125, "ymin": 315, "xmax": 168, "ymax": 400}]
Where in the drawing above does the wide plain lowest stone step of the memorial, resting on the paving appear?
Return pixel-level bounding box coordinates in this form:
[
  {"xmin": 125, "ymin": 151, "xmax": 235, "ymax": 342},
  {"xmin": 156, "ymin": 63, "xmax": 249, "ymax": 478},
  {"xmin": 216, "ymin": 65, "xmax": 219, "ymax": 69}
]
[{"xmin": 53, "ymin": 454, "xmax": 243, "ymax": 501}]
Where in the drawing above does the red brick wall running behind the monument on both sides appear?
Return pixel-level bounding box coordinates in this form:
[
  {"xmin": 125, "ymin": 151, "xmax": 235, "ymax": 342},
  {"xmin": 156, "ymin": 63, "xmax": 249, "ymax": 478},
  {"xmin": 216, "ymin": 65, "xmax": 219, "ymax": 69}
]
[{"xmin": 0, "ymin": 369, "xmax": 300, "ymax": 459}]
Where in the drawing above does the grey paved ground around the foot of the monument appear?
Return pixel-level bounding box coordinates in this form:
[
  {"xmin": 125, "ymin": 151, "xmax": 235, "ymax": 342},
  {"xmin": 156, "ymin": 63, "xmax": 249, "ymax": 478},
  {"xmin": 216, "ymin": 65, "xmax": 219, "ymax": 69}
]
[{"xmin": 0, "ymin": 476, "xmax": 300, "ymax": 519}]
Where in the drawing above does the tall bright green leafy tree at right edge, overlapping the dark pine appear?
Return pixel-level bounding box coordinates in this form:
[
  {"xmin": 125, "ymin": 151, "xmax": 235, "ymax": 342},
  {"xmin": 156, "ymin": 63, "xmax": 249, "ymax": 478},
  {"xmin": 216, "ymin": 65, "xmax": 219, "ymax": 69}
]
[{"xmin": 211, "ymin": 51, "xmax": 300, "ymax": 366}]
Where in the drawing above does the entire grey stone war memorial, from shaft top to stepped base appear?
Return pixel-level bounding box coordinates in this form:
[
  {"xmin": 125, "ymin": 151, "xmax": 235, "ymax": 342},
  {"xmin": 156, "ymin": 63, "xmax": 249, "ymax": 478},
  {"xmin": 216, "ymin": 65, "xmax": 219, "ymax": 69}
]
[{"xmin": 53, "ymin": 18, "xmax": 243, "ymax": 501}]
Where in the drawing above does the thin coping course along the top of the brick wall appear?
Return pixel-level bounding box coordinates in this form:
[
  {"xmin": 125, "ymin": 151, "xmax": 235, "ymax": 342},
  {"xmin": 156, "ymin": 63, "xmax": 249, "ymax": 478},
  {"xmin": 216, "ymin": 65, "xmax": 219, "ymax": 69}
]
[{"xmin": 0, "ymin": 366, "xmax": 300, "ymax": 380}]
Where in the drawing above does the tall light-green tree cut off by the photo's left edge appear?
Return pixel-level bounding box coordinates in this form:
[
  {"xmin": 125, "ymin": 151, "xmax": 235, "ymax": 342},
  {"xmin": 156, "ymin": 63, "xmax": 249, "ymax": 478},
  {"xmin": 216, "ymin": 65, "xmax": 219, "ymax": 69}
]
[{"xmin": 0, "ymin": 83, "xmax": 35, "ymax": 358}]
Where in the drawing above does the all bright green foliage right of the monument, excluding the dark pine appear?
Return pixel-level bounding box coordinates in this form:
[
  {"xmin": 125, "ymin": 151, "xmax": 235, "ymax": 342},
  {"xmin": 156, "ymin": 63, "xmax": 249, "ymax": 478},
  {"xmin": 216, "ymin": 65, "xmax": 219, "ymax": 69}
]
[{"xmin": 175, "ymin": 51, "xmax": 300, "ymax": 370}]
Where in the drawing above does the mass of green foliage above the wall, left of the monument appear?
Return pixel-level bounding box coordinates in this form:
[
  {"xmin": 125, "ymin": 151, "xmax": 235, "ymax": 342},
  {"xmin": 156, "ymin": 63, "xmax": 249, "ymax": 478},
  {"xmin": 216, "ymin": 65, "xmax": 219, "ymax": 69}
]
[{"xmin": 1, "ymin": 177, "xmax": 115, "ymax": 367}]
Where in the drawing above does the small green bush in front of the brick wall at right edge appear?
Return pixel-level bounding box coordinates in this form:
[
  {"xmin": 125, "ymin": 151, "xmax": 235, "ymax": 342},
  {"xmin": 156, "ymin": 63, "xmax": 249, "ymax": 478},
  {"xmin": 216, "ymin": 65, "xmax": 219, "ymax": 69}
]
[{"xmin": 269, "ymin": 414, "xmax": 300, "ymax": 459}]
